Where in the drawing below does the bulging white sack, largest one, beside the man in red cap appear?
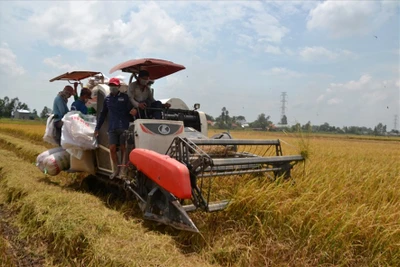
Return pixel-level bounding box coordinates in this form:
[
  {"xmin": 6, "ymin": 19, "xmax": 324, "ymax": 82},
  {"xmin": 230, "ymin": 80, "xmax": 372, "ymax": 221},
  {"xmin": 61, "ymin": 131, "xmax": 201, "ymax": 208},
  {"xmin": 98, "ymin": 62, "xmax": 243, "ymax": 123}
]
[{"xmin": 61, "ymin": 111, "xmax": 97, "ymax": 150}]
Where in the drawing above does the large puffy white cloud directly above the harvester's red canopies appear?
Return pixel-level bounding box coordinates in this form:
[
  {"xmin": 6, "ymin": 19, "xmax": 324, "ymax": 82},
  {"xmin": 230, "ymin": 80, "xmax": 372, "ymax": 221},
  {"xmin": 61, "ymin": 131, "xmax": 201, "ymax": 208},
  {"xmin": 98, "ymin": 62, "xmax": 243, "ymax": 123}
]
[{"xmin": 29, "ymin": 2, "xmax": 196, "ymax": 57}]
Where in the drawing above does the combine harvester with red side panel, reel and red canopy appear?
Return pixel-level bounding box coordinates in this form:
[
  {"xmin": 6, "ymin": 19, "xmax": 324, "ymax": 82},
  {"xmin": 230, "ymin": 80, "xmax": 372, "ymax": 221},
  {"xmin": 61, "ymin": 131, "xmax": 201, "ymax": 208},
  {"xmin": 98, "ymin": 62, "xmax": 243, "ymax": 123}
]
[{"xmin": 41, "ymin": 59, "xmax": 304, "ymax": 232}]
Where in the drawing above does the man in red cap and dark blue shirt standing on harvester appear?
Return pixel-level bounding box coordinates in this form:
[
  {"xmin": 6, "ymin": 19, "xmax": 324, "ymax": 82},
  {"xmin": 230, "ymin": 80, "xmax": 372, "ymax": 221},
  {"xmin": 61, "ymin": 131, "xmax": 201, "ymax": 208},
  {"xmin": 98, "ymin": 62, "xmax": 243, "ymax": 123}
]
[{"xmin": 94, "ymin": 78, "xmax": 136, "ymax": 179}]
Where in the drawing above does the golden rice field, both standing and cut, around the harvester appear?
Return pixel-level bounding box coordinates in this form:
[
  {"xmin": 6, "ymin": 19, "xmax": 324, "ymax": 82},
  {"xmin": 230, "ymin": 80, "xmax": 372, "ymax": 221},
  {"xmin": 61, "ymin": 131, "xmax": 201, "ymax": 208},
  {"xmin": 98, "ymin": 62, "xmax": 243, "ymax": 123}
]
[{"xmin": 0, "ymin": 120, "xmax": 400, "ymax": 266}]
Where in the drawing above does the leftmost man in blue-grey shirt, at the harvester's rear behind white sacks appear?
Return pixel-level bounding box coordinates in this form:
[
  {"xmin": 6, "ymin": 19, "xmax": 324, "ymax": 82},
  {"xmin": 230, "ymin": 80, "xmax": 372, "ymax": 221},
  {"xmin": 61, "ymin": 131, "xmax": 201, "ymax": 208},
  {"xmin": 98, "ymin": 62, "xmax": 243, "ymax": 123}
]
[{"xmin": 53, "ymin": 83, "xmax": 78, "ymax": 145}]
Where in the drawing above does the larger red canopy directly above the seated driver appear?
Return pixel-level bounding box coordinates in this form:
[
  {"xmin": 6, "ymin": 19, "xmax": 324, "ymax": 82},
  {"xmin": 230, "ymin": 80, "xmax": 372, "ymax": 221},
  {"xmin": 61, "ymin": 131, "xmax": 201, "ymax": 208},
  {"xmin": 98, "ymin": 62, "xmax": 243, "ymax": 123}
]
[{"xmin": 110, "ymin": 58, "xmax": 185, "ymax": 80}]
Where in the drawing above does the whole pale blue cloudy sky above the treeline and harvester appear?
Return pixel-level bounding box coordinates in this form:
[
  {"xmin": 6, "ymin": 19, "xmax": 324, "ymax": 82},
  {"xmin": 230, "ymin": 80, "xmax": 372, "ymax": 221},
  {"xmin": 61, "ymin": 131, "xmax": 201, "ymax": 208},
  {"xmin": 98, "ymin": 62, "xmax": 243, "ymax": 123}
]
[{"xmin": 0, "ymin": 1, "xmax": 400, "ymax": 129}]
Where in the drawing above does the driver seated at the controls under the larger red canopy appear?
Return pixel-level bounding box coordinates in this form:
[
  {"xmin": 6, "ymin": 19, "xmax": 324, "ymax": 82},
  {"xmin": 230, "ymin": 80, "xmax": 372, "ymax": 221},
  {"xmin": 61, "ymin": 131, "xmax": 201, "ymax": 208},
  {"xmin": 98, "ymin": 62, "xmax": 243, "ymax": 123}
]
[{"xmin": 128, "ymin": 70, "xmax": 171, "ymax": 119}]
